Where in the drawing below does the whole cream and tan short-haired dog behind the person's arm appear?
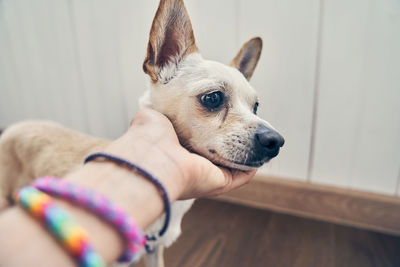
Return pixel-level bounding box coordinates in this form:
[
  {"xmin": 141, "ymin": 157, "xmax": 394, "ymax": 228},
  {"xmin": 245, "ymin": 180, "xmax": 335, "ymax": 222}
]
[{"xmin": 0, "ymin": 0, "xmax": 284, "ymax": 266}]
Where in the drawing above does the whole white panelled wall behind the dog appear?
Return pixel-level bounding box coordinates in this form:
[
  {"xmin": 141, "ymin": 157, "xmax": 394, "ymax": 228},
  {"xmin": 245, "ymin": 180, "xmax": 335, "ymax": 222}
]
[{"xmin": 0, "ymin": 0, "xmax": 400, "ymax": 195}]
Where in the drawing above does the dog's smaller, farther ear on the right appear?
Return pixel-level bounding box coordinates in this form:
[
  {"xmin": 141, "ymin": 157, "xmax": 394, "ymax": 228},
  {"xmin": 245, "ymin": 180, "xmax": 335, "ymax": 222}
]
[{"xmin": 230, "ymin": 37, "xmax": 262, "ymax": 80}]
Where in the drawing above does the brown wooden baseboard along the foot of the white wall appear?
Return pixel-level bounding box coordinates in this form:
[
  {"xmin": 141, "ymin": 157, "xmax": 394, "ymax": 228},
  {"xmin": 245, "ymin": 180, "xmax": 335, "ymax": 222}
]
[{"xmin": 216, "ymin": 176, "xmax": 400, "ymax": 235}]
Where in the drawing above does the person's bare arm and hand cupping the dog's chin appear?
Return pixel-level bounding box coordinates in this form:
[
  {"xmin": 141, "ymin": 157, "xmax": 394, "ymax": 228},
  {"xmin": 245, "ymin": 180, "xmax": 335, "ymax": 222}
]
[{"xmin": 0, "ymin": 110, "xmax": 255, "ymax": 266}]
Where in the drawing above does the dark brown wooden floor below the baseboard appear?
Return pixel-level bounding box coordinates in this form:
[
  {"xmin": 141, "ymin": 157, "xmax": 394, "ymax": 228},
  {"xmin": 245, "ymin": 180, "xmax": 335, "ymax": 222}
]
[{"xmin": 137, "ymin": 200, "xmax": 400, "ymax": 267}]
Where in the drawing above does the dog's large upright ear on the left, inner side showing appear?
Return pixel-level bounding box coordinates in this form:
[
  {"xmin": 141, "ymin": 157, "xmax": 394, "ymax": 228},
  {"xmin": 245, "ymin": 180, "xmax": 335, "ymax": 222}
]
[{"xmin": 143, "ymin": 0, "xmax": 198, "ymax": 83}]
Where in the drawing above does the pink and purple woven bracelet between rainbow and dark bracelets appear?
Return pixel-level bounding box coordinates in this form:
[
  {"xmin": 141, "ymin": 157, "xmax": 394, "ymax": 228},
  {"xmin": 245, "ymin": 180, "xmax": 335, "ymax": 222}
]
[{"xmin": 32, "ymin": 177, "xmax": 146, "ymax": 262}]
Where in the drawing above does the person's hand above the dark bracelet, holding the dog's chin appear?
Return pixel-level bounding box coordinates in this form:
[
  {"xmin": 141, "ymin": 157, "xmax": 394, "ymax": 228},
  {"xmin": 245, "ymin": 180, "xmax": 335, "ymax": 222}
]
[{"xmin": 106, "ymin": 109, "xmax": 255, "ymax": 199}]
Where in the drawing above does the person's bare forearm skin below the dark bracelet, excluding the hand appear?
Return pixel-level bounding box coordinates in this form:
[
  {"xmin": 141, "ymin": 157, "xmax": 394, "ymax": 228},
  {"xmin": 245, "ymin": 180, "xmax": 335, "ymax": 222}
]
[{"xmin": 0, "ymin": 162, "xmax": 178, "ymax": 266}]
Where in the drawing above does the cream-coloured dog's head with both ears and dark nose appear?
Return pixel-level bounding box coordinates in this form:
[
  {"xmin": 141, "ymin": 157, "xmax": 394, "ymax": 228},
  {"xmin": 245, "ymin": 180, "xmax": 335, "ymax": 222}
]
[{"xmin": 143, "ymin": 0, "xmax": 284, "ymax": 170}]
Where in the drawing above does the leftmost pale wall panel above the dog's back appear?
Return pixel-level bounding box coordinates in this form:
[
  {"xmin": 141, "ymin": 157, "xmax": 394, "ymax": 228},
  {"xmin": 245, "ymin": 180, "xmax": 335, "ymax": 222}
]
[{"xmin": 0, "ymin": 0, "xmax": 86, "ymax": 130}]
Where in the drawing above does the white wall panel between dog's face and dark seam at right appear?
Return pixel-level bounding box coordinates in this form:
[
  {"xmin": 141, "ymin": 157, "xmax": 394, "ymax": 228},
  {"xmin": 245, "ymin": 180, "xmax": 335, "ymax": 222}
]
[{"xmin": 238, "ymin": 0, "xmax": 319, "ymax": 180}]
